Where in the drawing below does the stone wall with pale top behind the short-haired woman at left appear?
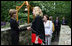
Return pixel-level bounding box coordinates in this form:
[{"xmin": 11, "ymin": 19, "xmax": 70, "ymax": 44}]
[{"xmin": 1, "ymin": 24, "xmax": 32, "ymax": 45}]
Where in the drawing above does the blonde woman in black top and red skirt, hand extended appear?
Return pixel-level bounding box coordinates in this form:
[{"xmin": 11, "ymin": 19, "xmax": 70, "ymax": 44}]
[{"xmin": 27, "ymin": 6, "xmax": 45, "ymax": 45}]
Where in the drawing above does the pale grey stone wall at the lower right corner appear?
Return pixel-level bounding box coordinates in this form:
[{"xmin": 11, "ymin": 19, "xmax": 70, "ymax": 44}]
[{"xmin": 58, "ymin": 25, "xmax": 71, "ymax": 45}]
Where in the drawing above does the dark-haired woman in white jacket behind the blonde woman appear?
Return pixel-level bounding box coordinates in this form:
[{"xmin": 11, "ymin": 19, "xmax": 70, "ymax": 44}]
[{"xmin": 43, "ymin": 15, "xmax": 53, "ymax": 45}]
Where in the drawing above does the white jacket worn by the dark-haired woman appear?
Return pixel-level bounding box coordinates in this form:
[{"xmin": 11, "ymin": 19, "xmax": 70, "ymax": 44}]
[{"xmin": 44, "ymin": 20, "xmax": 53, "ymax": 36}]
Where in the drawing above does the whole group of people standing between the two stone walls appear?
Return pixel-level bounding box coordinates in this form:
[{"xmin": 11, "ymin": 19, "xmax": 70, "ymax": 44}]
[{"xmin": 9, "ymin": 6, "xmax": 66, "ymax": 45}]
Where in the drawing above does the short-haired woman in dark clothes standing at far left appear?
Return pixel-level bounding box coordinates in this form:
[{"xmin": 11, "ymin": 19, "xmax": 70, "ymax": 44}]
[{"xmin": 9, "ymin": 9, "xmax": 19, "ymax": 45}]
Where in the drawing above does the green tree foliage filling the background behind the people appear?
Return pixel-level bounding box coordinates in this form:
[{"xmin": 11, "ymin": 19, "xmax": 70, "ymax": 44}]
[{"xmin": 1, "ymin": 1, "xmax": 71, "ymax": 27}]
